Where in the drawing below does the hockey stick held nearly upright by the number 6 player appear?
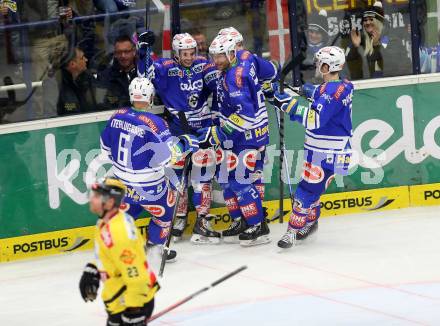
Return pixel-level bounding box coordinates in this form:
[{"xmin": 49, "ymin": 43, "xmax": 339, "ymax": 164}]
[{"xmin": 159, "ymin": 111, "xmax": 191, "ymax": 277}]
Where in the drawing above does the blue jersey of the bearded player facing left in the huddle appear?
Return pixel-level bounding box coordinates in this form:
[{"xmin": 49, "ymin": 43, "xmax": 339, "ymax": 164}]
[{"xmin": 211, "ymin": 57, "xmax": 269, "ymax": 146}]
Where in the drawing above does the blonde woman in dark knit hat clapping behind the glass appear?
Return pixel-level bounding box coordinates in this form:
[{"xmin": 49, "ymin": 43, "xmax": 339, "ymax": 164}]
[{"xmin": 347, "ymin": 1, "xmax": 412, "ymax": 78}]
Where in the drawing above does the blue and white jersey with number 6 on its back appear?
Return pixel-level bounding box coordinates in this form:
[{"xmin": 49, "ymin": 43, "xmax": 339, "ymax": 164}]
[{"xmin": 101, "ymin": 107, "xmax": 172, "ymax": 187}]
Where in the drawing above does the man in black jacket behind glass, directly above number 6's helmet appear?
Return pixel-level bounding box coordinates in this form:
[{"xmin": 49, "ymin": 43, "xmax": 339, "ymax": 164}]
[{"xmin": 98, "ymin": 35, "xmax": 137, "ymax": 109}]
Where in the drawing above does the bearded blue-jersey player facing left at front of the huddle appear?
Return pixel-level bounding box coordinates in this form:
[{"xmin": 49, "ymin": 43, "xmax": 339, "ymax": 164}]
[{"xmin": 199, "ymin": 35, "xmax": 270, "ymax": 246}]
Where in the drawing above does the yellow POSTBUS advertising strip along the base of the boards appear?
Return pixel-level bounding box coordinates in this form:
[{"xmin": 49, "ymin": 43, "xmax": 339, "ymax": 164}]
[{"xmin": 0, "ymin": 183, "xmax": 440, "ymax": 262}]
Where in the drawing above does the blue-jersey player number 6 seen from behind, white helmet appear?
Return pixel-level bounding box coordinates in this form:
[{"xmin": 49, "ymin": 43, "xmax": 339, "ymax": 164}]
[{"xmin": 101, "ymin": 77, "xmax": 199, "ymax": 271}]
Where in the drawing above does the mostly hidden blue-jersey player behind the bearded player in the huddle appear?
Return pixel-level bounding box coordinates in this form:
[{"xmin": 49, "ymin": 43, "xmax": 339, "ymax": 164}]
[{"xmin": 218, "ymin": 26, "xmax": 279, "ymax": 222}]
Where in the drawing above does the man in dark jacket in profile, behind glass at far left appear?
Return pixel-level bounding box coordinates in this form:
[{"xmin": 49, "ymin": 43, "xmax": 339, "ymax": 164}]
[{"xmin": 57, "ymin": 48, "xmax": 97, "ymax": 115}]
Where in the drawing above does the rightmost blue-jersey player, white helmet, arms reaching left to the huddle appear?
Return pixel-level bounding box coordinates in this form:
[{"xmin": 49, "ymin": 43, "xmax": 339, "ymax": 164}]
[{"xmin": 274, "ymin": 46, "xmax": 353, "ymax": 248}]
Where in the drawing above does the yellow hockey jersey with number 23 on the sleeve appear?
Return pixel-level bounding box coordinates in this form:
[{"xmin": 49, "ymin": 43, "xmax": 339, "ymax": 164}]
[{"xmin": 95, "ymin": 211, "xmax": 159, "ymax": 314}]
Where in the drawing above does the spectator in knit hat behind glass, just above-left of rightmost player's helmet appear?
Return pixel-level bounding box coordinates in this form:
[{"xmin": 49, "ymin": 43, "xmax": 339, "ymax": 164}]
[{"xmin": 301, "ymin": 9, "xmax": 329, "ymax": 84}]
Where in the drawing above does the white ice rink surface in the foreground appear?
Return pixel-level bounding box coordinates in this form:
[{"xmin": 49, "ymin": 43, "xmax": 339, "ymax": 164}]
[{"xmin": 0, "ymin": 207, "xmax": 440, "ymax": 326}]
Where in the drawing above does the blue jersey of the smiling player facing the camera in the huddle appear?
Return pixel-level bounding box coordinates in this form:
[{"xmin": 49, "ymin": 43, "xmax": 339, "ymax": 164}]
[{"xmin": 149, "ymin": 57, "xmax": 217, "ymax": 135}]
